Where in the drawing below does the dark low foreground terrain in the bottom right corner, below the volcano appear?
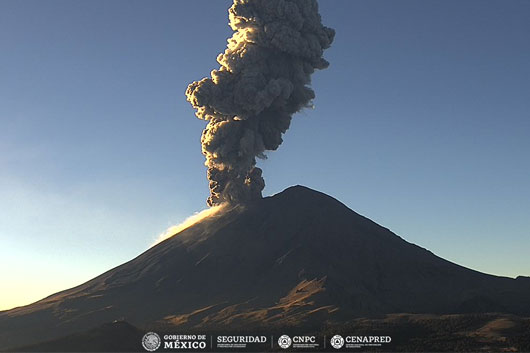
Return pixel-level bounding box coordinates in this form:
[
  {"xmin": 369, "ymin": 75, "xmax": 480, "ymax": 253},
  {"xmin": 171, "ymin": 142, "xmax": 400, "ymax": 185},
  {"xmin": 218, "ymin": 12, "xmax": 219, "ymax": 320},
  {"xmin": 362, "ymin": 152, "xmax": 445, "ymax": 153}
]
[{"xmin": 327, "ymin": 314, "xmax": 530, "ymax": 352}]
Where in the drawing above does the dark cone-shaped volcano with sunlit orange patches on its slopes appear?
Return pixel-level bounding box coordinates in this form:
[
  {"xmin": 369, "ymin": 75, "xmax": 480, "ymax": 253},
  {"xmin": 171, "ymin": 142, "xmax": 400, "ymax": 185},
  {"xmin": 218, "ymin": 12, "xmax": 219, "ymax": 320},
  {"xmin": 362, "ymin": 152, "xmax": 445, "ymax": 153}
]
[{"xmin": 0, "ymin": 186, "xmax": 530, "ymax": 349}]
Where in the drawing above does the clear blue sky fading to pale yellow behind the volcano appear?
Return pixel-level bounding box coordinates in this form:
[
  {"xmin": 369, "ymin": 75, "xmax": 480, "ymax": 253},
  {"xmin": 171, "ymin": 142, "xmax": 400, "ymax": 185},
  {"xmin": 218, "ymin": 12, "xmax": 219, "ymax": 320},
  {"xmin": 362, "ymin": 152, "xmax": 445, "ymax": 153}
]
[{"xmin": 0, "ymin": 0, "xmax": 530, "ymax": 310}]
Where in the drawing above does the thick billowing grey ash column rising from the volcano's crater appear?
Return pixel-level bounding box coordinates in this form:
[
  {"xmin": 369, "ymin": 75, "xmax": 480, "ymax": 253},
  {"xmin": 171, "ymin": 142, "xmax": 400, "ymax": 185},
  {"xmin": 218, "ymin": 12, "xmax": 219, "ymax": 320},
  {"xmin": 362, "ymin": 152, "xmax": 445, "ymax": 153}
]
[{"xmin": 186, "ymin": 0, "xmax": 335, "ymax": 206}]
